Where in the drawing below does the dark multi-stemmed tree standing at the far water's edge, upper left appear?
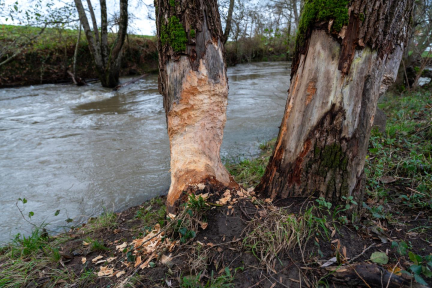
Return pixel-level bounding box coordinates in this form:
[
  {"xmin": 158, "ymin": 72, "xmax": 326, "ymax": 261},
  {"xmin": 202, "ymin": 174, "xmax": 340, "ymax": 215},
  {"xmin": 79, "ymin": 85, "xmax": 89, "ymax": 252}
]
[{"xmin": 75, "ymin": 0, "xmax": 128, "ymax": 88}]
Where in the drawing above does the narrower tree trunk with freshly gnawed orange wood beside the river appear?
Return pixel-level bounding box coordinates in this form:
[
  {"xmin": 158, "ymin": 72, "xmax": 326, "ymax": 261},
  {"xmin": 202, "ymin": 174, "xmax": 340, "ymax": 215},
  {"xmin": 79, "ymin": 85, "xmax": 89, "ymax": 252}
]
[{"xmin": 155, "ymin": 0, "xmax": 236, "ymax": 213}]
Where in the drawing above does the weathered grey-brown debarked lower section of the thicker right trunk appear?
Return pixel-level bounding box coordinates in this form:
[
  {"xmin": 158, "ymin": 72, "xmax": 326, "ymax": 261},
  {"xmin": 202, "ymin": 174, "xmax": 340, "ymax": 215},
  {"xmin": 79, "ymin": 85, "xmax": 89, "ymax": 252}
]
[{"xmin": 257, "ymin": 30, "xmax": 402, "ymax": 201}]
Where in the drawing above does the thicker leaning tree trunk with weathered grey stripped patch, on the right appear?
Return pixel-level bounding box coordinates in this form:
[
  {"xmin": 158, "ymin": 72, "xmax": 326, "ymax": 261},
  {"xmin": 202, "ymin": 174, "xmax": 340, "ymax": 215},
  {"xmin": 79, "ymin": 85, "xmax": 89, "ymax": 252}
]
[{"xmin": 256, "ymin": 0, "xmax": 414, "ymax": 207}]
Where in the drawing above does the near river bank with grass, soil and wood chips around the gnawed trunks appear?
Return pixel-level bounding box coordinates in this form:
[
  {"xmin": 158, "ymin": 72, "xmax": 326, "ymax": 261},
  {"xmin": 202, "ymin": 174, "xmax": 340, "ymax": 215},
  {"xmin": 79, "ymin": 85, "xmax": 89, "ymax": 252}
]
[{"xmin": 0, "ymin": 91, "xmax": 432, "ymax": 288}]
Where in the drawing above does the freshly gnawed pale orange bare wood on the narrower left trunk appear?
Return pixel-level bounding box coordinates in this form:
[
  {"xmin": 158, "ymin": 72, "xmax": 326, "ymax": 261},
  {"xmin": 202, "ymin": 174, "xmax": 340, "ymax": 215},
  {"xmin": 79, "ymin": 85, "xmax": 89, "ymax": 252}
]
[{"xmin": 167, "ymin": 57, "xmax": 235, "ymax": 212}]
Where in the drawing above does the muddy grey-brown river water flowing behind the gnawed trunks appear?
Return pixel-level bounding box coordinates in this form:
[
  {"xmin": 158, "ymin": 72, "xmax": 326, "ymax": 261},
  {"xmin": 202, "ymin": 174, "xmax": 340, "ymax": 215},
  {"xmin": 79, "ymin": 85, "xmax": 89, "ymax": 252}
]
[{"xmin": 0, "ymin": 62, "xmax": 289, "ymax": 243}]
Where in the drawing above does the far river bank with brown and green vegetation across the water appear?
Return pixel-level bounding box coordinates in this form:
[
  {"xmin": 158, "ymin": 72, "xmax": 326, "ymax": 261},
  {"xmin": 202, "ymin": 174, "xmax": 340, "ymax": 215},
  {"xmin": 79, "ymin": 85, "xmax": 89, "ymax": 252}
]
[{"xmin": 0, "ymin": 25, "xmax": 288, "ymax": 88}]
